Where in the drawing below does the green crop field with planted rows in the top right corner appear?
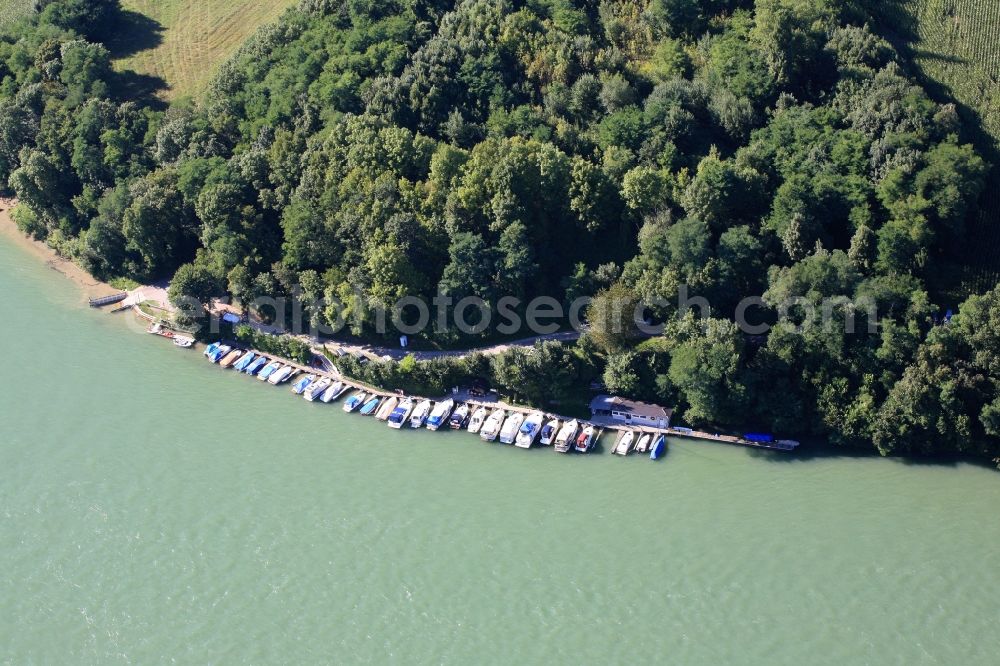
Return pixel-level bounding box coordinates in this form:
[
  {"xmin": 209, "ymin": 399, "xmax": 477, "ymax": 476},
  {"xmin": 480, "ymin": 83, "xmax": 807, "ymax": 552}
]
[{"xmin": 874, "ymin": 0, "xmax": 1000, "ymax": 300}]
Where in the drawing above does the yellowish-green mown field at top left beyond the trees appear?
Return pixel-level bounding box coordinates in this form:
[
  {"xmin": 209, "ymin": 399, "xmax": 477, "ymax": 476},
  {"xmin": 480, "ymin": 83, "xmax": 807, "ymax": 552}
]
[{"xmin": 113, "ymin": 0, "xmax": 295, "ymax": 99}]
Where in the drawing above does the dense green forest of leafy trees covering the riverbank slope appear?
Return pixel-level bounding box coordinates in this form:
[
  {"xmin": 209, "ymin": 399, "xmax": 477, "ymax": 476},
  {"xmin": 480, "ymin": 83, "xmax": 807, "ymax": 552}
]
[{"xmin": 0, "ymin": 0, "xmax": 1000, "ymax": 457}]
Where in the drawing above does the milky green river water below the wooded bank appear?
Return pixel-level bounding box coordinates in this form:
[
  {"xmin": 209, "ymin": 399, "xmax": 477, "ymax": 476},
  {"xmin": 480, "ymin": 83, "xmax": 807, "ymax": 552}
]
[{"xmin": 0, "ymin": 239, "xmax": 1000, "ymax": 666}]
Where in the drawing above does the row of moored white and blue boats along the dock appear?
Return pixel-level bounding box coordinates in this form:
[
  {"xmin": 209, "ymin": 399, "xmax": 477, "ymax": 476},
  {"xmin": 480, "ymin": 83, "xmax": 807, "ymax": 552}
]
[{"xmin": 205, "ymin": 342, "xmax": 666, "ymax": 460}]
